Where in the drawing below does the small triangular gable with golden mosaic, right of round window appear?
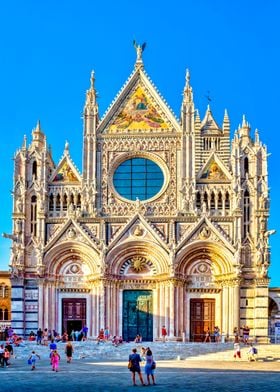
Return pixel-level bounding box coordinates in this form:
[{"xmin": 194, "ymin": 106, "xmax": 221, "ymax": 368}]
[{"xmin": 197, "ymin": 153, "xmax": 231, "ymax": 182}]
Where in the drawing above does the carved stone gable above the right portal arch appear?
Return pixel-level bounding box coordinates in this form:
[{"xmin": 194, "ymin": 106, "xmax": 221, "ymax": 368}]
[{"xmin": 178, "ymin": 216, "xmax": 234, "ymax": 253}]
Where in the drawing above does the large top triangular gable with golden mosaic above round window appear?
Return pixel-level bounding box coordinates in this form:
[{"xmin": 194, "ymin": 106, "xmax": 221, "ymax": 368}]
[{"xmin": 98, "ymin": 69, "xmax": 180, "ymax": 134}]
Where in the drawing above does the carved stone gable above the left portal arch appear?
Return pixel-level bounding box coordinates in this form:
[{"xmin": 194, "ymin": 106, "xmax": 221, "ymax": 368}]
[{"xmin": 45, "ymin": 218, "xmax": 98, "ymax": 251}]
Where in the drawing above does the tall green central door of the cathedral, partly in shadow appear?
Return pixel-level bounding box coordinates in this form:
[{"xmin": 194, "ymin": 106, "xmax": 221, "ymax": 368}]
[{"xmin": 123, "ymin": 290, "xmax": 153, "ymax": 341}]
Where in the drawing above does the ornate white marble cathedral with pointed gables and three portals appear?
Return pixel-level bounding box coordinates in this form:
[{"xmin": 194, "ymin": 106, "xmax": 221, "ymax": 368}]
[{"xmin": 5, "ymin": 44, "xmax": 272, "ymax": 341}]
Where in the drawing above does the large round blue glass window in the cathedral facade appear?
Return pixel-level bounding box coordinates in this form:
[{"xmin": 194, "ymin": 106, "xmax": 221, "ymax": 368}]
[{"xmin": 113, "ymin": 158, "xmax": 164, "ymax": 201}]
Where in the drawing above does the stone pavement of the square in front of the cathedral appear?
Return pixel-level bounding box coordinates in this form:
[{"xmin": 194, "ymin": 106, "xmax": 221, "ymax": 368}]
[{"xmin": 0, "ymin": 343, "xmax": 280, "ymax": 392}]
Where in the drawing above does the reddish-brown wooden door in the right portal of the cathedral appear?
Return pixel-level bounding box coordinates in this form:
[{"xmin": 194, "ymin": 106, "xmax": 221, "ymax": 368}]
[{"xmin": 190, "ymin": 299, "xmax": 215, "ymax": 342}]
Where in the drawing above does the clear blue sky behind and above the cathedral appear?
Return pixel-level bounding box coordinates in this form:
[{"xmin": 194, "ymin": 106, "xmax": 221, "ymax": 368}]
[{"xmin": 0, "ymin": 0, "xmax": 280, "ymax": 286}]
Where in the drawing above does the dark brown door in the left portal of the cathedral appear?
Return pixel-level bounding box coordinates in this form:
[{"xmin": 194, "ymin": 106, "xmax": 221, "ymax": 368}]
[{"xmin": 62, "ymin": 298, "xmax": 86, "ymax": 334}]
